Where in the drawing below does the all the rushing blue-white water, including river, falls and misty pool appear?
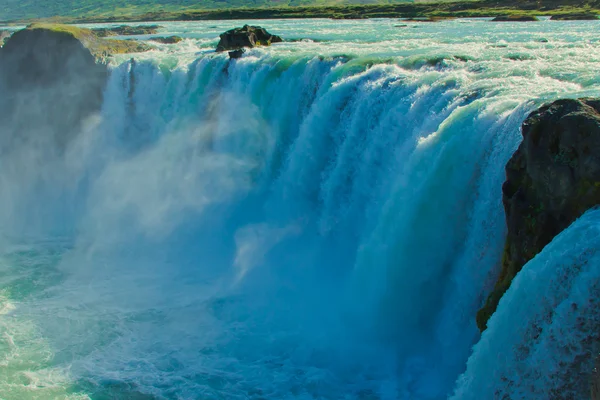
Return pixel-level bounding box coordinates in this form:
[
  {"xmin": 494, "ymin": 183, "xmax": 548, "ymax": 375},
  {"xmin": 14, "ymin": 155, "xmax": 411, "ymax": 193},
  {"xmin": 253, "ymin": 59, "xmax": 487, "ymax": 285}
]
[{"xmin": 0, "ymin": 20, "xmax": 600, "ymax": 400}]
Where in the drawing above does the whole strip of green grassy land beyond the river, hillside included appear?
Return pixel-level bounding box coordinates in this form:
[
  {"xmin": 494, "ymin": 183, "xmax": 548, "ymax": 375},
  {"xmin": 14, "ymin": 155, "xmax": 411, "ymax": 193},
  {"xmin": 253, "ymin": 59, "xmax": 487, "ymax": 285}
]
[{"xmin": 0, "ymin": 0, "xmax": 600, "ymax": 23}]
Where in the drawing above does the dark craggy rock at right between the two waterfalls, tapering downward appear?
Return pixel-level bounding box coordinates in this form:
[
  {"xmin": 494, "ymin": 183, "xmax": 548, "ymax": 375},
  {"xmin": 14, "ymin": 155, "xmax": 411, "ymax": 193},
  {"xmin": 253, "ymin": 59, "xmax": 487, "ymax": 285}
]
[{"xmin": 477, "ymin": 99, "xmax": 600, "ymax": 330}]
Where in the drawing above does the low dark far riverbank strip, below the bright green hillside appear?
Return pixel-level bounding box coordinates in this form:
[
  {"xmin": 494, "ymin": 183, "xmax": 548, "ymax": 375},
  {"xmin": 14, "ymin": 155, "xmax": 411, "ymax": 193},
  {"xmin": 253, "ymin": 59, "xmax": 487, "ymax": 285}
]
[{"xmin": 2, "ymin": 0, "xmax": 600, "ymax": 24}]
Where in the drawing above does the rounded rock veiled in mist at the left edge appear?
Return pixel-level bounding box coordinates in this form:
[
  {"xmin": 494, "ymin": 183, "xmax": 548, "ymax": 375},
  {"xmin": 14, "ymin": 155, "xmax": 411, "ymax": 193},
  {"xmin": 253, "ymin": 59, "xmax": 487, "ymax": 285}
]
[{"xmin": 0, "ymin": 29, "xmax": 108, "ymax": 153}]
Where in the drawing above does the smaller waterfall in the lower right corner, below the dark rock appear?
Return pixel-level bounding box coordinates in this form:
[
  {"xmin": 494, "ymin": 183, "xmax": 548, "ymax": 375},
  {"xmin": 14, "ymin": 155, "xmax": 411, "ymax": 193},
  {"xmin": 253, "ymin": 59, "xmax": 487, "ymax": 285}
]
[{"xmin": 453, "ymin": 210, "xmax": 600, "ymax": 400}]
